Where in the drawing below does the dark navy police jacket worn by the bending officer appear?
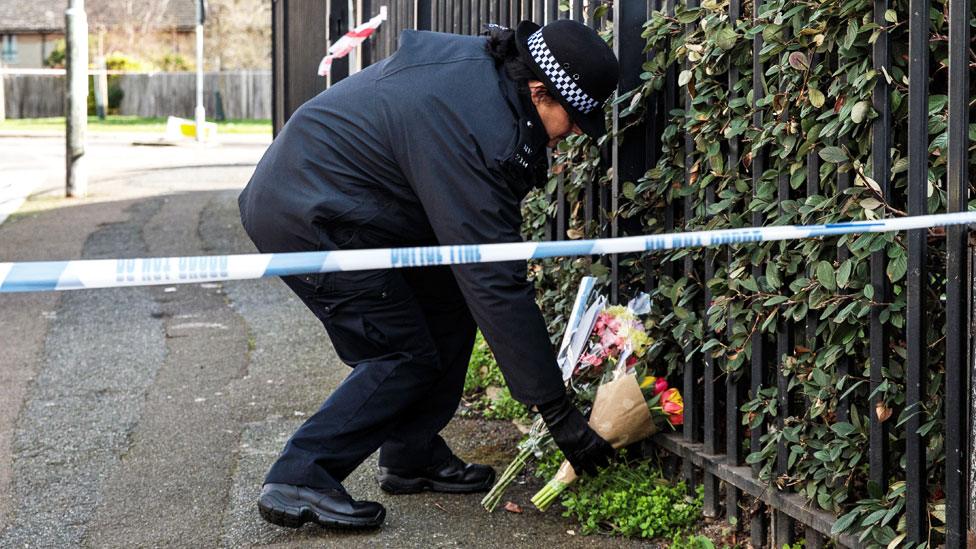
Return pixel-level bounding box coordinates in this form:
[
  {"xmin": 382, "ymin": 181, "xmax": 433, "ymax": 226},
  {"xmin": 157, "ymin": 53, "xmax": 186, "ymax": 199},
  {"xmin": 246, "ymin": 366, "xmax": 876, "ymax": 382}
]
[{"xmin": 239, "ymin": 30, "xmax": 564, "ymax": 405}]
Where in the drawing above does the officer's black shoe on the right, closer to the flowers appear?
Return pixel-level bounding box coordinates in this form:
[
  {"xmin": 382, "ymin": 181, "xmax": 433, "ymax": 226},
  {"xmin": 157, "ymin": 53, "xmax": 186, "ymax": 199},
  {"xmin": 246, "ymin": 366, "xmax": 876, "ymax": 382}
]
[{"xmin": 377, "ymin": 455, "xmax": 495, "ymax": 494}]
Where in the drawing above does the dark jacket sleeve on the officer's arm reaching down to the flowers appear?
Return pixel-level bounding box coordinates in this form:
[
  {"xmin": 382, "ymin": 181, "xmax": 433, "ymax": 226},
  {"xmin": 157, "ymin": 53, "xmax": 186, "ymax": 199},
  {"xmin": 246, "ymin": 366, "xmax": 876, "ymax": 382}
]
[{"xmin": 386, "ymin": 105, "xmax": 565, "ymax": 406}]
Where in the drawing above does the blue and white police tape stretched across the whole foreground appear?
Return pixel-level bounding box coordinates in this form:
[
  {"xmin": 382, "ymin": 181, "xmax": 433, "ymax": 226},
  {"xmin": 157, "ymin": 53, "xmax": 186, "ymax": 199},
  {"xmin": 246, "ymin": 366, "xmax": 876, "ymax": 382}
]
[{"xmin": 0, "ymin": 211, "xmax": 976, "ymax": 293}]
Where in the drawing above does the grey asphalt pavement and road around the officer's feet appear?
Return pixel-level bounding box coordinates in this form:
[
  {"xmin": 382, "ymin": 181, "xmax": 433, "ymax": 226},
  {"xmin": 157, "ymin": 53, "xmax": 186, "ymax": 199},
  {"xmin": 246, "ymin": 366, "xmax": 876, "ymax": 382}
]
[{"xmin": 0, "ymin": 138, "xmax": 656, "ymax": 547}]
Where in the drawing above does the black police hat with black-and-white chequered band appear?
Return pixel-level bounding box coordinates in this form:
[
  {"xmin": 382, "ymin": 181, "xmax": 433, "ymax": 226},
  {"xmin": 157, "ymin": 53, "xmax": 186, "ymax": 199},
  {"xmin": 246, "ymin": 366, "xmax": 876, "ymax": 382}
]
[{"xmin": 515, "ymin": 19, "xmax": 620, "ymax": 138}]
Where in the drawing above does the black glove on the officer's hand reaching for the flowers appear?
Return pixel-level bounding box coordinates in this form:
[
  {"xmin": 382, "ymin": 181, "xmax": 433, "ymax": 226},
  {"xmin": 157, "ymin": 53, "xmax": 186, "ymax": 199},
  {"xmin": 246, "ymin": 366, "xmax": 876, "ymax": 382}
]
[{"xmin": 537, "ymin": 395, "xmax": 614, "ymax": 475}]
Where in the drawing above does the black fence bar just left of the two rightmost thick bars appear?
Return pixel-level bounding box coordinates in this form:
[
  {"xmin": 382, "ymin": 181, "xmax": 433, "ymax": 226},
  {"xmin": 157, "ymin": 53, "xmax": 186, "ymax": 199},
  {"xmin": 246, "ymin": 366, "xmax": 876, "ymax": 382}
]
[{"xmin": 868, "ymin": 0, "xmax": 892, "ymax": 500}]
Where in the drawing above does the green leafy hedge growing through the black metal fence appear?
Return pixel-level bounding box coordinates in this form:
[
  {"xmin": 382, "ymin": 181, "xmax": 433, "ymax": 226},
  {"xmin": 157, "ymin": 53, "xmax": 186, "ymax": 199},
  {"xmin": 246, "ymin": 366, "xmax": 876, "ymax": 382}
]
[{"xmin": 525, "ymin": 0, "xmax": 976, "ymax": 545}]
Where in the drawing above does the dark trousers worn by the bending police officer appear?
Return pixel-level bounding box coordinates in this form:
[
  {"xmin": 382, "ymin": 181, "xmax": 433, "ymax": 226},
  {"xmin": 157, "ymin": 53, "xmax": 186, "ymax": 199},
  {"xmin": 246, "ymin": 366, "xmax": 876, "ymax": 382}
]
[{"xmin": 265, "ymin": 267, "xmax": 475, "ymax": 490}]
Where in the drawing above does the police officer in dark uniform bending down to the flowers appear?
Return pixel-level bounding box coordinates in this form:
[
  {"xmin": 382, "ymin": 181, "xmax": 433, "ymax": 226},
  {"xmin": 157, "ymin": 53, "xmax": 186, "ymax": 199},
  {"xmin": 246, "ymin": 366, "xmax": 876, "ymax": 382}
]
[{"xmin": 239, "ymin": 21, "xmax": 618, "ymax": 528}]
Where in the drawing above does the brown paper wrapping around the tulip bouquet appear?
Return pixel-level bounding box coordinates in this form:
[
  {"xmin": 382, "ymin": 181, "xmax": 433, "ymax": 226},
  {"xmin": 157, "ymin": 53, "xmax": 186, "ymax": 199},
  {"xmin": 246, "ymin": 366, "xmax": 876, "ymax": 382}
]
[{"xmin": 553, "ymin": 374, "xmax": 658, "ymax": 484}]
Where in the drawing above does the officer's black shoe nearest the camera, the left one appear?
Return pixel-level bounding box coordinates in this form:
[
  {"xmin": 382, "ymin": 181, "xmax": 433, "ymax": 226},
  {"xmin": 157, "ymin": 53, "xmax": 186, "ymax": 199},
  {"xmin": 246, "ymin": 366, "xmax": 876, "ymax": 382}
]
[{"xmin": 258, "ymin": 484, "xmax": 386, "ymax": 529}]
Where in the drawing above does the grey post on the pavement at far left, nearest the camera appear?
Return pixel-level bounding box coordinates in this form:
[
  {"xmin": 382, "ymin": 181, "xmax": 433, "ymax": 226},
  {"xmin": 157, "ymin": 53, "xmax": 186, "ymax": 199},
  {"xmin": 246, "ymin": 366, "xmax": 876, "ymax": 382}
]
[{"xmin": 64, "ymin": 0, "xmax": 88, "ymax": 198}]
